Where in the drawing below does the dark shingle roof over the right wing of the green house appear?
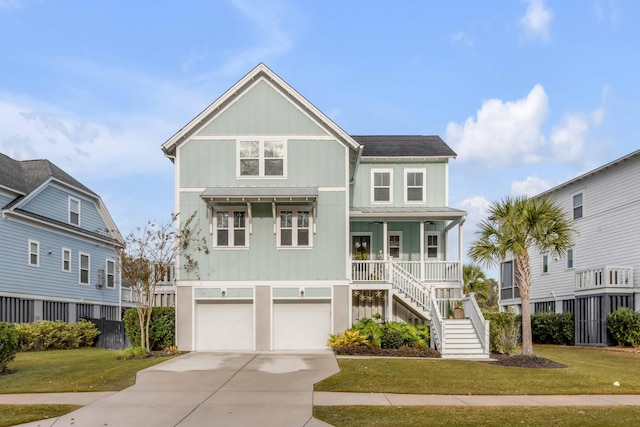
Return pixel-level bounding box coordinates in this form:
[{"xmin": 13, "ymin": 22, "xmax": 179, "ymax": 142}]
[{"xmin": 351, "ymin": 135, "xmax": 457, "ymax": 157}]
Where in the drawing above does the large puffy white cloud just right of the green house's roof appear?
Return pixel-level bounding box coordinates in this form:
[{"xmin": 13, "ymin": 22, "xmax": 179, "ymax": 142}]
[{"xmin": 446, "ymin": 85, "xmax": 549, "ymax": 167}]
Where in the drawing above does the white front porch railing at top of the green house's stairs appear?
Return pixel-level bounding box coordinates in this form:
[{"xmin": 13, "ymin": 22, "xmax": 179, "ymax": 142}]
[{"xmin": 351, "ymin": 260, "xmax": 461, "ymax": 282}]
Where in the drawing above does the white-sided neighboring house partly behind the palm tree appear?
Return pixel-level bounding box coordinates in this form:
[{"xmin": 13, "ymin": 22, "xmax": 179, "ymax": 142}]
[{"xmin": 500, "ymin": 150, "xmax": 640, "ymax": 345}]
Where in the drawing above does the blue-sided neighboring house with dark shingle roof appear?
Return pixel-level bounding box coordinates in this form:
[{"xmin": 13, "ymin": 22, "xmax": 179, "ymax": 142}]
[{"xmin": 0, "ymin": 154, "xmax": 123, "ymax": 323}]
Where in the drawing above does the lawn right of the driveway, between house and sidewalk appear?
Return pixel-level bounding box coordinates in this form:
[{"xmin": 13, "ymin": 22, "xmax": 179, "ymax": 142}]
[{"xmin": 315, "ymin": 345, "xmax": 640, "ymax": 395}]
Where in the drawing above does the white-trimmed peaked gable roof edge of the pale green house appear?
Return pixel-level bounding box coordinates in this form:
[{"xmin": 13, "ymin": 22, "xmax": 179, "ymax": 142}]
[{"xmin": 162, "ymin": 62, "xmax": 360, "ymax": 158}]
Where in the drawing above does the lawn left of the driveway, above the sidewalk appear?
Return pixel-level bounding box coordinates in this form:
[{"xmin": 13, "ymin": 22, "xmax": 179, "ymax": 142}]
[{"xmin": 0, "ymin": 348, "xmax": 169, "ymax": 393}]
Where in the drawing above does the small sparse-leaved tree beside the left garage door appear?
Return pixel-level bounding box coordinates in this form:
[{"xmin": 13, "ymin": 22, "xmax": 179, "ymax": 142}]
[{"xmin": 119, "ymin": 212, "xmax": 209, "ymax": 352}]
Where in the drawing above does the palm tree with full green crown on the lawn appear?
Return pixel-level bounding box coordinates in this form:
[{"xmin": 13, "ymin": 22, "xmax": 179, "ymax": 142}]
[{"xmin": 469, "ymin": 197, "xmax": 576, "ymax": 356}]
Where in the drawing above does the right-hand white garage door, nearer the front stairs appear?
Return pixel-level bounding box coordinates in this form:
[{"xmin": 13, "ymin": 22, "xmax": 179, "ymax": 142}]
[{"xmin": 273, "ymin": 301, "xmax": 331, "ymax": 350}]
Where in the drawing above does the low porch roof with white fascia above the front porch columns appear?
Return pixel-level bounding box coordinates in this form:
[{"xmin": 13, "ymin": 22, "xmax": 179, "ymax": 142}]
[{"xmin": 349, "ymin": 206, "xmax": 467, "ymax": 221}]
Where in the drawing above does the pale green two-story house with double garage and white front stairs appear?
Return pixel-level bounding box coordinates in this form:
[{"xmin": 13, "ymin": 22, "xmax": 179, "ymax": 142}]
[{"xmin": 162, "ymin": 64, "xmax": 488, "ymax": 357}]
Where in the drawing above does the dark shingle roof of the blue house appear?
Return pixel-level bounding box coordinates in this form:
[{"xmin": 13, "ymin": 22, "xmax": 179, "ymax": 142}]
[{"xmin": 0, "ymin": 153, "xmax": 97, "ymax": 196}]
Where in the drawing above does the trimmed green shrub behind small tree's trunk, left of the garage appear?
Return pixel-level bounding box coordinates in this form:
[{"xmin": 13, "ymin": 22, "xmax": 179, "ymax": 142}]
[{"xmin": 123, "ymin": 307, "xmax": 175, "ymax": 351}]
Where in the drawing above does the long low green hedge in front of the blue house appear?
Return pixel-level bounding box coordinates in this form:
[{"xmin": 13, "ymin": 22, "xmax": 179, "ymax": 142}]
[{"xmin": 15, "ymin": 319, "xmax": 100, "ymax": 351}]
